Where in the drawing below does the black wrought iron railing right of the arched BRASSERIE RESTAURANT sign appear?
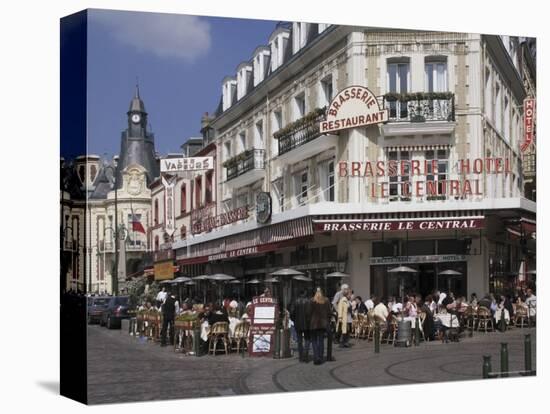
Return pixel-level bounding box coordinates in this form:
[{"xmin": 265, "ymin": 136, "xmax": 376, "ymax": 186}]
[{"xmin": 383, "ymin": 92, "xmax": 455, "ymax": 122}]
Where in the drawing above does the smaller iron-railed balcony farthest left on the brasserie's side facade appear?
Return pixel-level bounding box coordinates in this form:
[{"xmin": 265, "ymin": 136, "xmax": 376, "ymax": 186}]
[{"xmin": 223, "ymin": 148, "xmax": 265, "ymax": 187}]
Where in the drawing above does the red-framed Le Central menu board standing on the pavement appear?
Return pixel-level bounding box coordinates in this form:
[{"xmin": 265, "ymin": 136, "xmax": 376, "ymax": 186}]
[{"xmin": 248, "ymin": 296, "xmax": 279, "ymax": 357}]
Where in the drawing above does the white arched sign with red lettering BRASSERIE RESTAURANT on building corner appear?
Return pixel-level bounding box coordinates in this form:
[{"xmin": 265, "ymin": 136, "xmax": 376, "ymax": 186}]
[{"xmin": 320, "ymin": 86, "xmax": 388, "ymax": 133}]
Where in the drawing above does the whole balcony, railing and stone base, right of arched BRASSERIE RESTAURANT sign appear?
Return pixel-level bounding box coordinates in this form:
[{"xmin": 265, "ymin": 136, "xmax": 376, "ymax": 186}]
[{"xmin": 382, "ymin": 92, "xmax": 455, "ymax": 135}]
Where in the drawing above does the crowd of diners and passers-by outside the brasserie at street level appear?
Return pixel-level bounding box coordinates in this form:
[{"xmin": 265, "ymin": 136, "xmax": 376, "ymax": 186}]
[{"xmin": 138, "ymin": 284, "xmax": 536, "ymax": 365}]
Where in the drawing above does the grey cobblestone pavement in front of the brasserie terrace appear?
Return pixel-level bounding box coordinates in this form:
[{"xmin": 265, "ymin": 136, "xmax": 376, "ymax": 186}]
[{"xmin": 88, "ymin": 325, "xmax": 536, "ymax": 404}]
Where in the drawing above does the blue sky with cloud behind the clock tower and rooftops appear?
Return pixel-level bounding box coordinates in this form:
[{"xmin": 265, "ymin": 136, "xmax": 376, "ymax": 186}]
[{"xmin": 88, "ymin": 10, "xmax": 276, "ymax": 157}]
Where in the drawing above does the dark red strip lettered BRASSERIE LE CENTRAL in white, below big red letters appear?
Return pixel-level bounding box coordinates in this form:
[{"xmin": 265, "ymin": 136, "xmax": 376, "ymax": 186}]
[{"xmin": 313, "ymin": 218, "xmax": 485, "ymax": 233}]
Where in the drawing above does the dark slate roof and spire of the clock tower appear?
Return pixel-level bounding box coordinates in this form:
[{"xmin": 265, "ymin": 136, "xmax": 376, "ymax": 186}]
[{"xmin": 117, "ymin": 85, "xmax": 159, "ymax": 188}]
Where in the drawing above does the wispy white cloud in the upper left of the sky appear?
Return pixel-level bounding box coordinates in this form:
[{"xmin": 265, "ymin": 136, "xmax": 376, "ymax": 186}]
[{"xmin": 90, "ymin": 11, "xmax": 211, "ymax": 62}]
